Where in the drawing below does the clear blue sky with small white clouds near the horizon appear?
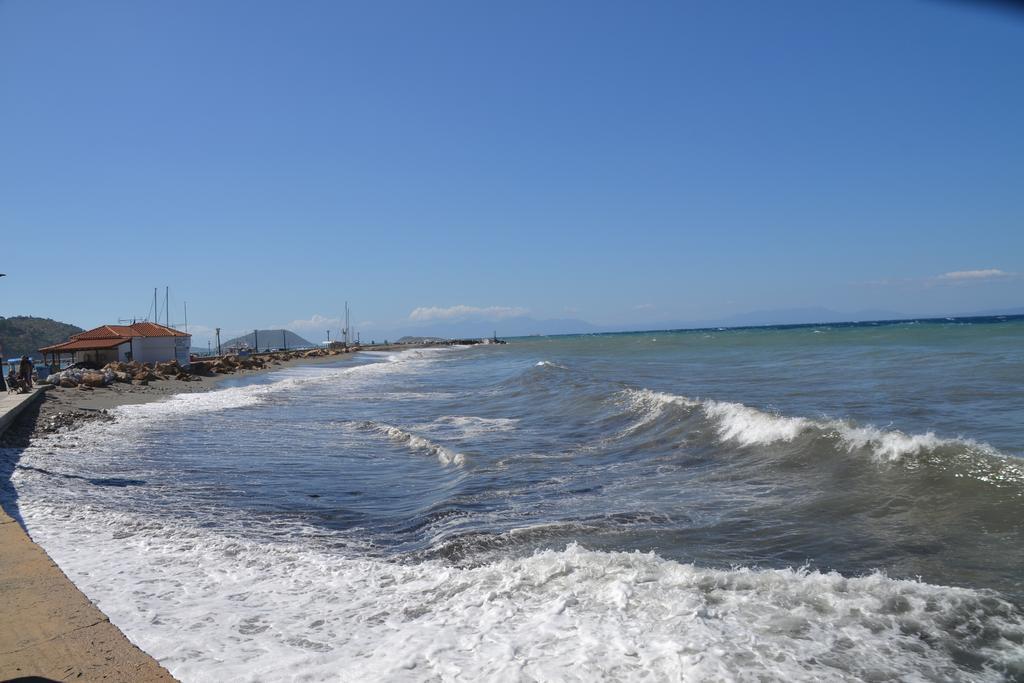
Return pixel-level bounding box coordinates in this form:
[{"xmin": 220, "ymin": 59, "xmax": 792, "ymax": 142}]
[{"xmin": 0, "ymin": 0, "xmax": 1024, "ymax": 344}]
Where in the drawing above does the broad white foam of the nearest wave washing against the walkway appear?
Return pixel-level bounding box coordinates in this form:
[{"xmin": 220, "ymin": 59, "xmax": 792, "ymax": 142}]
[{"xmin": 16, "ymin": 500, "xmax": 1024, "ymax": 682}]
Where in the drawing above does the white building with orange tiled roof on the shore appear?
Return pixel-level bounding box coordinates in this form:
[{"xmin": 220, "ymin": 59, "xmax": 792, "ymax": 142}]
[{"xmin": 39, "ymin": 323, "xmax": 191, "ymax": 366}]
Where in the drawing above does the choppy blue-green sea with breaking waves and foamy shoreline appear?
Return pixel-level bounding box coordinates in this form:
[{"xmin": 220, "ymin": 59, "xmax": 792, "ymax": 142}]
[{"xmin": 2, "ymin": 316, "xmax": 1024, "ymax": 682}]
